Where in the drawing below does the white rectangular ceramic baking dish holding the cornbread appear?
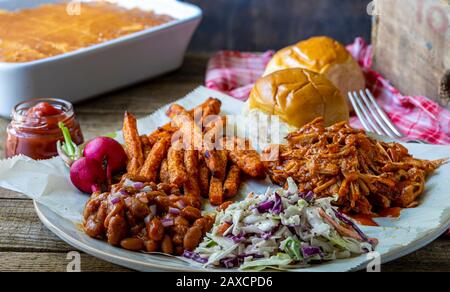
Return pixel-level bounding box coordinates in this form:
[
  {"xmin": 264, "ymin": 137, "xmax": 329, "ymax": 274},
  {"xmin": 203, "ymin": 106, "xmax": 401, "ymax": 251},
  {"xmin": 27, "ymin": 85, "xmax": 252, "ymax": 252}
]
[{"xmin": 0, "ymin": 0, "xmax": 202, "ymax": 117}]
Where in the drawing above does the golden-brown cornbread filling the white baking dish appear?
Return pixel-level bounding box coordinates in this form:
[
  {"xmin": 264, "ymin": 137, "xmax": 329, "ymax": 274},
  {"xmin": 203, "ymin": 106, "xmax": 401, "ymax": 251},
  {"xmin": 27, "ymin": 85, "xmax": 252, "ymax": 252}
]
[{"xmin": 0, "ymin": 2, "xmax": 173, "ymax": 63}]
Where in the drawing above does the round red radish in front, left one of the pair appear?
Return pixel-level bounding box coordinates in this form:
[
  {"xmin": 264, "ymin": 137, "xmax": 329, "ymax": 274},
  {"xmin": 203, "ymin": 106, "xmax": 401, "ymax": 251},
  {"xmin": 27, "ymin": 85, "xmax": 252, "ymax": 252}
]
[{"xmin": 70, "ymin": 157, "xmax": 106, "ymax": 194}]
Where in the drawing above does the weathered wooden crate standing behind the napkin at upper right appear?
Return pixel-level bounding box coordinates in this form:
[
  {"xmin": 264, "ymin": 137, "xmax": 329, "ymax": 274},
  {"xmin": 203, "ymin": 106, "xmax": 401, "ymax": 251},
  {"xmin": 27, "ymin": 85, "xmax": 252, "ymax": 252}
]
[{"xmin": 372, "ymin": 0, "xmax": 450, "ymax": 108}]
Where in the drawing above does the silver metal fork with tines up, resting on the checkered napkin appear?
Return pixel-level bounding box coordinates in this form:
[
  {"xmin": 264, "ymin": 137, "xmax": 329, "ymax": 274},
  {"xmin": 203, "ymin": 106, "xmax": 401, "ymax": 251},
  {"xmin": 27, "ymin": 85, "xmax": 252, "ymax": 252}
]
[{"xmin": 348, "ymin": 89, "xmax": 428, "ymax": 144}]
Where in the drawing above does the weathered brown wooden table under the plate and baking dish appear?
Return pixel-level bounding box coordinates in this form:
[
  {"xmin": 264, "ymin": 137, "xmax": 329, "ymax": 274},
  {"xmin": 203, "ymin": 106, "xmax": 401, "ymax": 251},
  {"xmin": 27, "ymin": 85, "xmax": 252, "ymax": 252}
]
[{"xmin": 0, "ymin": 54, "xmax": 450, "ymax": 272}]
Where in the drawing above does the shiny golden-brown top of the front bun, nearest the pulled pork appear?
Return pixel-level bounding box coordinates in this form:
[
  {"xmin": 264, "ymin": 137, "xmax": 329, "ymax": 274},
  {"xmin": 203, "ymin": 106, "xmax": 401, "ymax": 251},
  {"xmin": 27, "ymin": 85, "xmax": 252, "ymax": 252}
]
[{"xmin": 247, "ymin": 68, "xmax": 349, "ymax": 128}]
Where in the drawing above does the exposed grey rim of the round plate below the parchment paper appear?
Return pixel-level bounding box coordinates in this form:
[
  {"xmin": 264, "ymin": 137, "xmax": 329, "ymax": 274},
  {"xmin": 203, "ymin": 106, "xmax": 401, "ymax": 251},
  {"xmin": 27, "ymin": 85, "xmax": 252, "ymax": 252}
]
[{"xmin": 34, "ymin": 197, "xmax": 450, "ymax": 272}]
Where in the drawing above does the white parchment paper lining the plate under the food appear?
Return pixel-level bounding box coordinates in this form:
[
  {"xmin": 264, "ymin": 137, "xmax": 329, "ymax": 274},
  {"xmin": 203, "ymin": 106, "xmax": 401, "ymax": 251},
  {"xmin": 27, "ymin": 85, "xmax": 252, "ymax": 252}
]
[{"xmin": 0, "ymin": 87, "xmax": 450, "ymax": 271}]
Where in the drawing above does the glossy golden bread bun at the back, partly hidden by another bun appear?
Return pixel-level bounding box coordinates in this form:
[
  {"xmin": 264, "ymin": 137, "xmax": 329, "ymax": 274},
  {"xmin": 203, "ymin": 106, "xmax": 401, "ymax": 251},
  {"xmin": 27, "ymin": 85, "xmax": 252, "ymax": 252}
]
[{"xmin": 264, "ymin": 36, "xmax": 366, "ymax": 100}]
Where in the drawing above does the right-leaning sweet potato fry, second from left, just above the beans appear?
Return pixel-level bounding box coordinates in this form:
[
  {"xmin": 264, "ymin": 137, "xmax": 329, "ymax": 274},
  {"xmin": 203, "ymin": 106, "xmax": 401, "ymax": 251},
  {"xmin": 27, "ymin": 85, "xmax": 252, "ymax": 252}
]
[{"xmin": 140, "ymin": 134, "xmax": 170, "ymax": 182}]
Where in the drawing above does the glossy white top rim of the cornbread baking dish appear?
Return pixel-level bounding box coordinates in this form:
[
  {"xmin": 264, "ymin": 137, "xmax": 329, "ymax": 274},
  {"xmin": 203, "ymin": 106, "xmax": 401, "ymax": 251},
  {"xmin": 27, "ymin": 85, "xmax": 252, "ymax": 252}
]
[{"xmin": 0, "ymin": 0, "xmax": 203, "ymax": 69}]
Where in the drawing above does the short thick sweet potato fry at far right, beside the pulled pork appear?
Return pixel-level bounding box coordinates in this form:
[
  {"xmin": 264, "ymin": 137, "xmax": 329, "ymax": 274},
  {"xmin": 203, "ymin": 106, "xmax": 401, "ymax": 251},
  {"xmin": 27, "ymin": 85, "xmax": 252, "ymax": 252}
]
[{"xmin": 226, "ymin": 137, "xmax": 266, "ymax": 178}]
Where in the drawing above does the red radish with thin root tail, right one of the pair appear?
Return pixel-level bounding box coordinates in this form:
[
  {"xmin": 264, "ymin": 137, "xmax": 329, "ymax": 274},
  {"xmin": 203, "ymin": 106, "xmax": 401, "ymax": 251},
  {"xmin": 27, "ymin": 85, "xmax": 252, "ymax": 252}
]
[{"xmin": 83, "ymin": 137, "xmax": 128, "ymax": 182}]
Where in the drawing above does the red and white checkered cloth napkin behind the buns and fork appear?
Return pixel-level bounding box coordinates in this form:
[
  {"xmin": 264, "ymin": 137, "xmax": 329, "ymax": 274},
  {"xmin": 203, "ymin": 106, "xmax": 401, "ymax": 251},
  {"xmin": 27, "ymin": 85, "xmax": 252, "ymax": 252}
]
[{"xmin": 206, "ymin": 38, "xmax": 450, "ymax": 145}]
